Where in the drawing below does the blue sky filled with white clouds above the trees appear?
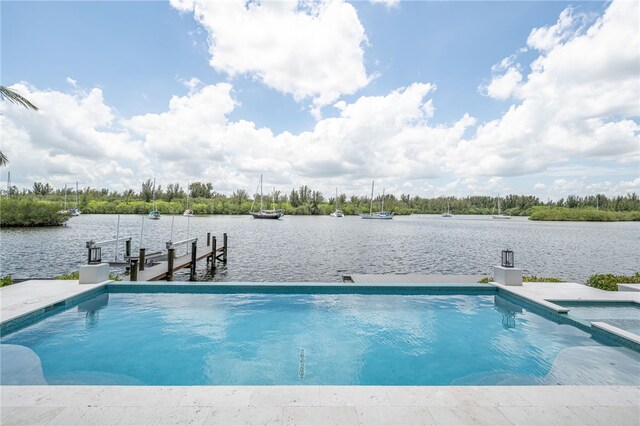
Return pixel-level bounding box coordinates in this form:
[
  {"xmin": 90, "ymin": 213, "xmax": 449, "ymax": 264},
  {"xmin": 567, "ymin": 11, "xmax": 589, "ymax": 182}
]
[{"xmin": 0, "ymin": 0, "xmax": 640, "ymax": 200}]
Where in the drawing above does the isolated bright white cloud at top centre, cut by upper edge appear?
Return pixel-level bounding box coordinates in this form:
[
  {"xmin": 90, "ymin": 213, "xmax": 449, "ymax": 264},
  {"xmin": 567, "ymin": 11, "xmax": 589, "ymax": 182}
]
[{"xmin": 171, "ymin": 0, "xmax": 371, "ymax": 112}]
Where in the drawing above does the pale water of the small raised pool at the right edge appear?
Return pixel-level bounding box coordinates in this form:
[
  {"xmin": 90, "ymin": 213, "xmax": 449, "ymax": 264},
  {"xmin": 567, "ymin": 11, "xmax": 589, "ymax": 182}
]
[{"xmin": 557, "ymin": 302, "xmax": 640, "ymax": 336}]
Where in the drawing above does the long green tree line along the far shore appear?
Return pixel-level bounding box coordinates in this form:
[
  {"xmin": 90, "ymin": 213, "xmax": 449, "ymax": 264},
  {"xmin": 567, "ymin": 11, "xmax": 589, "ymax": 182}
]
[{"xmin": 2, "ymin": 179, "xmax": 640, "ymax": 216}]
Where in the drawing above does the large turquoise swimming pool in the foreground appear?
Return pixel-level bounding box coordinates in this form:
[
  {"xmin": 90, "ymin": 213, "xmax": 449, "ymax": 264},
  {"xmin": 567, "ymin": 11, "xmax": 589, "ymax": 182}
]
[{"xmin": 0, "ymin": 284, "xmax": 640, "ymax": 385}]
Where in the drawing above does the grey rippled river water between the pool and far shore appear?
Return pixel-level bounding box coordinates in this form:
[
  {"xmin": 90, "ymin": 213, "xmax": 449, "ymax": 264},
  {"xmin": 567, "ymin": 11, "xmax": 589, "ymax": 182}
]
[{"xmin": 0, "ymin": 215, "xmax": 640, "ymax": 282}]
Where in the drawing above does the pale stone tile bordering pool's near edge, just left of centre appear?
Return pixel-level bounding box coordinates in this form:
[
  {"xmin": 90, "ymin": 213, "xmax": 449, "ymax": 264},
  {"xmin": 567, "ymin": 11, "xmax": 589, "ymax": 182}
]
[{"xmin": 250, "ymin": 386, "xmax": 320, "ymax": 407}]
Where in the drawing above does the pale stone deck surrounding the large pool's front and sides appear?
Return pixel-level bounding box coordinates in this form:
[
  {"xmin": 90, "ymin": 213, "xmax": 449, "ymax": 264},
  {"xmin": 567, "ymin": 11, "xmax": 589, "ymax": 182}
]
[{"xmin": 0, "ymin": 281, "xmax": 640, "ymax": 426}]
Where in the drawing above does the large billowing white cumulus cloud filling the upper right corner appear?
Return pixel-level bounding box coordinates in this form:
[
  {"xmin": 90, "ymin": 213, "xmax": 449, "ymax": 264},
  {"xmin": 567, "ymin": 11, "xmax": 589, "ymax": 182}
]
[{"xmin": 464, "ymin": 1, "xmax": 640, "ymax": 176}]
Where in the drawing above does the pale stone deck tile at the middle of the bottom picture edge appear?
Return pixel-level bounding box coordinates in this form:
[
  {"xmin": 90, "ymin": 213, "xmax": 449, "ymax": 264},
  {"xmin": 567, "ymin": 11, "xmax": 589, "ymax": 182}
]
[{"xmin": 282, "ymin": 407, "xmax": 359, "ymax": 426}]
